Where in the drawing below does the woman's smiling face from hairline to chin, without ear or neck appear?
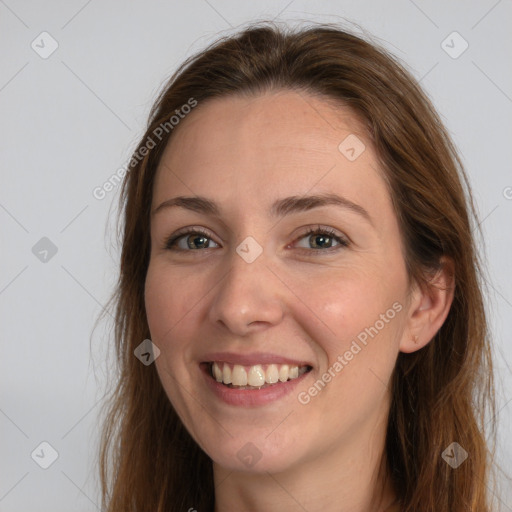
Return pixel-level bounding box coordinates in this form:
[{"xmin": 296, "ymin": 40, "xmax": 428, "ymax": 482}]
[{"xmin": 145, "ymin": 91, "xmax": 408, "ymax": 472}]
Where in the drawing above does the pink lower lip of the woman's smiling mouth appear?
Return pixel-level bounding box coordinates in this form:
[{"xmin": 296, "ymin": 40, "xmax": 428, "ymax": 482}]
[{"xmin": 201, "ymin": 365, "xmax": 312, "ymax": 407}]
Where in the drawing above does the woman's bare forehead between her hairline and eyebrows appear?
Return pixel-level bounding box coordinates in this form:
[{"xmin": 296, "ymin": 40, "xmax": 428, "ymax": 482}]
[{"xmin": 154, "ymin": 91, "xmax": 392, "ymax": 224}]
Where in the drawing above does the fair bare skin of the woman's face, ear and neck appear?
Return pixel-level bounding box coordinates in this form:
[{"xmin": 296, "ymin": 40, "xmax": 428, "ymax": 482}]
[{"xmin": 145, "ymin": 91, "xmax": 453, "ymax": 512}]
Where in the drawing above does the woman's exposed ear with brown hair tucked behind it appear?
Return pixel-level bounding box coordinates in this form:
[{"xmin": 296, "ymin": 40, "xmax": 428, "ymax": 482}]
[{"xmin": 400, "ymin": 256, "xmax": 455, "ymax": 353}]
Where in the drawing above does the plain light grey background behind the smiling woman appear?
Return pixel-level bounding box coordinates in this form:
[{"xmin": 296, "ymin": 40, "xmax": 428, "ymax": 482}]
[{"xmin": 0, "ymin": 0, "xmax": 512, "ymax": 512}]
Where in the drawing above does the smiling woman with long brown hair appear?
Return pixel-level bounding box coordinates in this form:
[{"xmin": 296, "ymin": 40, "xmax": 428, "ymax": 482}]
[{"xmin": 101, "ymin": 23, "xmax": 500, "ymax": 512}]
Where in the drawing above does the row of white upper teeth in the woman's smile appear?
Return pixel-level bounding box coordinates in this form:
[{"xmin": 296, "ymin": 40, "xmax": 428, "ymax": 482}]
[{"xmin": 212, "ymin": 362, "xmax": 308, "ymax": 386}]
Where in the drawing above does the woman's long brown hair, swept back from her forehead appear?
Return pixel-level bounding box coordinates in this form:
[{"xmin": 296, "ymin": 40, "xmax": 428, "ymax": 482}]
[{"xmin": 100, "ymin": 22, "xmax": 502, "ymax": 512}]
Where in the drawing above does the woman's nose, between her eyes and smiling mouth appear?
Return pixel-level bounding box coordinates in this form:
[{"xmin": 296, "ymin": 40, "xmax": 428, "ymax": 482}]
[{"xmin": 209, "ymin": 247, "xmax": 284, "ymax": 336}]
